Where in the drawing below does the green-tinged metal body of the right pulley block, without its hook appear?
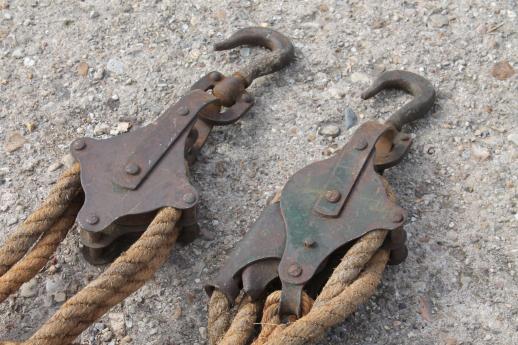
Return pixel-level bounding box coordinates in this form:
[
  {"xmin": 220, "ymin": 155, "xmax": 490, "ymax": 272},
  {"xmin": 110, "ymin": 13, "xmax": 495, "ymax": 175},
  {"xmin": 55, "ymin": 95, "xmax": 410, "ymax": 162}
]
[{"xmin": 207, "ymin": 122, "xmax": 406, "ymax": 315}]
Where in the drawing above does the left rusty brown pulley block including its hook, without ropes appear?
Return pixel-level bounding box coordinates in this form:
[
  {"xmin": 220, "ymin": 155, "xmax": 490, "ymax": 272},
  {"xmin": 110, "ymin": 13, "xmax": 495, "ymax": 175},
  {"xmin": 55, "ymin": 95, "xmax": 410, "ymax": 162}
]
[{"xmin": 71, "ymin": 27, "xmax": 294, "ymax": 264}]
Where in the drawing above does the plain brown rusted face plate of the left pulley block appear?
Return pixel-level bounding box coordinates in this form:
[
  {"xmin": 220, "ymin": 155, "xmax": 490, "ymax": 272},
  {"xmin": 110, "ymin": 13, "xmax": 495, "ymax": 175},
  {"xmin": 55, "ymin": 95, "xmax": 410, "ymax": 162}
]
[{"xmin": 71, "ymin": 90, "xmax": 216, "ymax": 232}]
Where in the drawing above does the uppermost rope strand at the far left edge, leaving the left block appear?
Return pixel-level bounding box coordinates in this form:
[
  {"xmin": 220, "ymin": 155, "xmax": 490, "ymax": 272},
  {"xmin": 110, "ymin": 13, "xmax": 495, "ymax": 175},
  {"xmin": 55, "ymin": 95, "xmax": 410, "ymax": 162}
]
[{"xmin": 0, "ymin": 163, "xmax": 81, "ymax": 276}]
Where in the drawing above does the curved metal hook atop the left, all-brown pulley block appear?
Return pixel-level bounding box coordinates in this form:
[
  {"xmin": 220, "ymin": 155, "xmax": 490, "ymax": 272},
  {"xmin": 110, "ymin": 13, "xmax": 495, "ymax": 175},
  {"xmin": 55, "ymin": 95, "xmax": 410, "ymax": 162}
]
[{"xmin": 214, "ymin": 27, "xmax": 295, "ymax": 87}]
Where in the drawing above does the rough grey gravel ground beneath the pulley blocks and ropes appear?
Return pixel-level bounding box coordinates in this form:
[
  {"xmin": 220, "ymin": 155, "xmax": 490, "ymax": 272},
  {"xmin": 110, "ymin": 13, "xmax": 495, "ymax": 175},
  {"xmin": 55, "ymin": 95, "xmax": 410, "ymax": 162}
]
[{"xmin": 0, "ymin": 0, "xmax": 518, "ymax": 345}]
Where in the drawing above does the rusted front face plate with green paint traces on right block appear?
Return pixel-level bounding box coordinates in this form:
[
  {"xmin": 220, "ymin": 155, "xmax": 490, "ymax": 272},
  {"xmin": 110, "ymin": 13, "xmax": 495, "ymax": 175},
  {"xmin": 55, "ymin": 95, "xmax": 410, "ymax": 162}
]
[{"xmin": 279, "ymin": 121, "xmax": 406, "ymax": 284}]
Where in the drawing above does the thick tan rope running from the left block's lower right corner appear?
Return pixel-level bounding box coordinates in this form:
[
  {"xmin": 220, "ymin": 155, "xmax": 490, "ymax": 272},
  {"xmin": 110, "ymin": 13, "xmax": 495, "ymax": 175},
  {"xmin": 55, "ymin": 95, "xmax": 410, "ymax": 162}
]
[{"xmin": 0, "ymin": 207, "xmax": 181, "ymax": 345}]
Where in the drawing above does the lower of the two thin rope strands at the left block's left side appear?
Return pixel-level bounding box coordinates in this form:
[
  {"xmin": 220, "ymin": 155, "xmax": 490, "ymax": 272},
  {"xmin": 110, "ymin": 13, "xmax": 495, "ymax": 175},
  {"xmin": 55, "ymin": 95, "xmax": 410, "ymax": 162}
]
[{"xmin": 0, "ymin": 200, "xmax": 80, "ymax": 303}]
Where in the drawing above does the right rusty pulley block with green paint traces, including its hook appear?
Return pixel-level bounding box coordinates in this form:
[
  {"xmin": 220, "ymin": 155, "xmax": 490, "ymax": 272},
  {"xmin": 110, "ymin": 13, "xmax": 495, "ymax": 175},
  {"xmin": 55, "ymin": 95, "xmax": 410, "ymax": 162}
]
[{"xmin": 207, "ymin": 71, "xmax": 435, "ymax": 316}]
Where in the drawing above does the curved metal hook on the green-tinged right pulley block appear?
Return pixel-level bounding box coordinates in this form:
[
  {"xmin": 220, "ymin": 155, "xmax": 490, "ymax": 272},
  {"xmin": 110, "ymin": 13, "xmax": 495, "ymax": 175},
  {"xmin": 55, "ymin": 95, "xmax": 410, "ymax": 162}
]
[{"xmin": 361, "ymin": 70, "xmax": 435, "ymax": 131}]
